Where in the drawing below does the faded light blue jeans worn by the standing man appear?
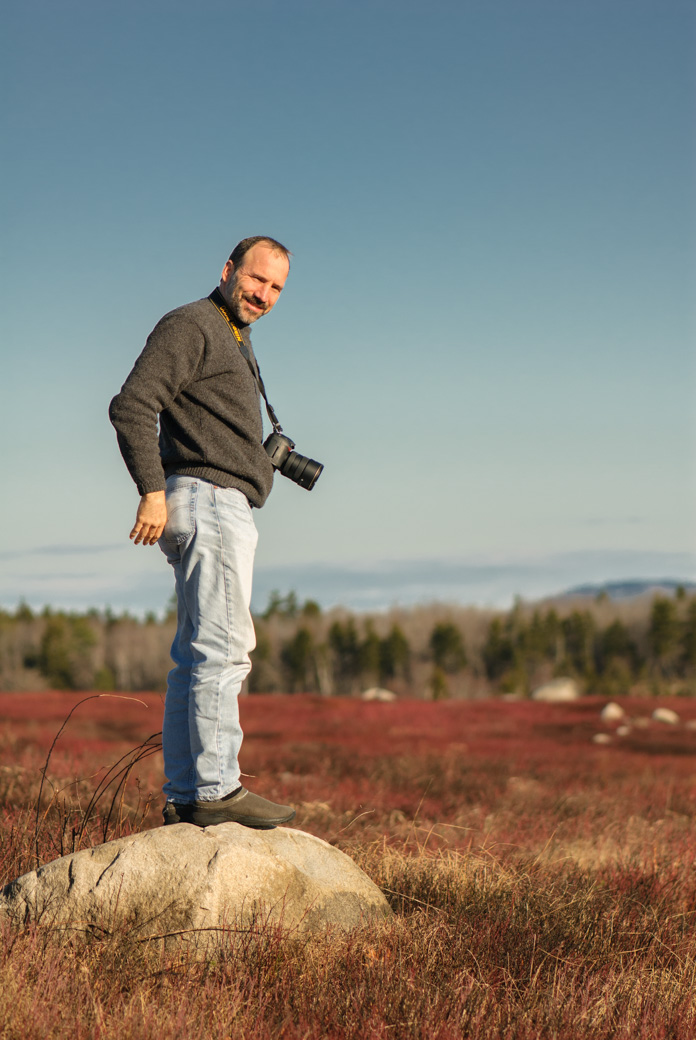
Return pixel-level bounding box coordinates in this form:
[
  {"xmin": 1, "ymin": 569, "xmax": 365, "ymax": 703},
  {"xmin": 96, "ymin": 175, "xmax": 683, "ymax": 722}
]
[{"xmin": 159, "ymin": 475, "xmax": 258, "ymax": 803}]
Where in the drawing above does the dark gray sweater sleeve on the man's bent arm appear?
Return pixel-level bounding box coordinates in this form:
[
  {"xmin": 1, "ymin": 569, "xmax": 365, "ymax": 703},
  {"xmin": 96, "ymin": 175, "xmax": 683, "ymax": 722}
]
[{"xmin": 109, "ymin": 313, "xmax": 205, "ymax": 495}]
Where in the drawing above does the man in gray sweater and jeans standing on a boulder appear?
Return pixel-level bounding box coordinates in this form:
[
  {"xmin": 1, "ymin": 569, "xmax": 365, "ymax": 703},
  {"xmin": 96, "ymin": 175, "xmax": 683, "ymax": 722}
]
[{"xmin": 109, "ymin": 236, "xmax": 294, "ymax": 828}]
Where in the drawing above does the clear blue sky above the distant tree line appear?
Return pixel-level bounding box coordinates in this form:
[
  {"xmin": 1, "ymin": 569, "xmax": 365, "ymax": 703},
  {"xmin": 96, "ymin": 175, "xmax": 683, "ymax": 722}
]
[{"xmin": 0, "ymin": 0, "xmax": 696, "ymax": 609}]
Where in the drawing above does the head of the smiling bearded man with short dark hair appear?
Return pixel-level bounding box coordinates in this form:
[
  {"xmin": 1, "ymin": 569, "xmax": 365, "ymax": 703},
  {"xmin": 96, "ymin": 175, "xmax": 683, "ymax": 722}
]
[{"xmin": 220, "ymin": 242, "xmax": 290, "ymax": 324}]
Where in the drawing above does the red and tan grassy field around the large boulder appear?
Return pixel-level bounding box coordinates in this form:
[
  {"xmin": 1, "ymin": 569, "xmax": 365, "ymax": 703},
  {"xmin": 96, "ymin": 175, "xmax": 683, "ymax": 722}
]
[{"xmin": 0, "ymin": 693, "xmax": 696, "ymax": 1040}]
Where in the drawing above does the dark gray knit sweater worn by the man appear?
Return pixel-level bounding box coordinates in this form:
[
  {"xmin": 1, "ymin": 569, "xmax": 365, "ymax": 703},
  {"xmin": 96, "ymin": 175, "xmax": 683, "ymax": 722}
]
[{"xmin": 109, "ymin": 298, "xmax": 274, "ymax": 506}]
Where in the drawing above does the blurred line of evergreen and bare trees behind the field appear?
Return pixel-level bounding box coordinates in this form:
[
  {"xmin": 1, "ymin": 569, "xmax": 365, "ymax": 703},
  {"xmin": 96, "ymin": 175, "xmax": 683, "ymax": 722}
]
[{"xmin": 0, "ymin": 589, "xmax": 696, "ymax": 698}]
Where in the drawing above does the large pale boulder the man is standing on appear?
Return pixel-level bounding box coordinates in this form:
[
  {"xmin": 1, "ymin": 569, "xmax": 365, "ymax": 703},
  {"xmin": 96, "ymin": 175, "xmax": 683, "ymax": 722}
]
[{"xmin": 0, "ymin": 824, "xmax": 391, "ymax": 951}]
